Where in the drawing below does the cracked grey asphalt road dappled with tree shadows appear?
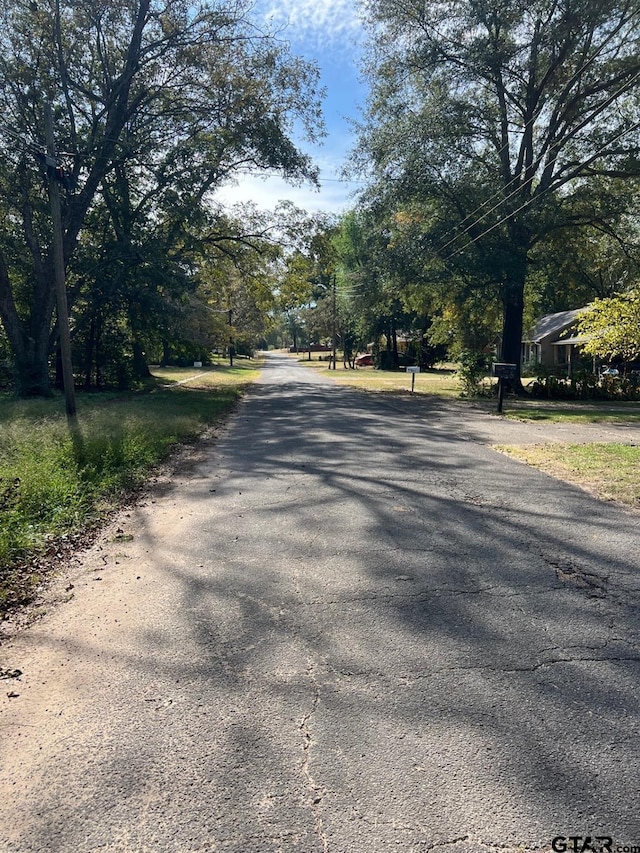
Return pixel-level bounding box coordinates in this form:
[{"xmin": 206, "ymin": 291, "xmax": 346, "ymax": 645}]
[{"xmin": 0, "ymin": 357, "xmax": 640, "ymax": 853}]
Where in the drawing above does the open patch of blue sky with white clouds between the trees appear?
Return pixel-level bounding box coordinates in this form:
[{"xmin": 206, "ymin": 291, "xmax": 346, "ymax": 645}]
[{"xmin": 217, "ymin": 0, "xmax": 366, "ymax": 213}]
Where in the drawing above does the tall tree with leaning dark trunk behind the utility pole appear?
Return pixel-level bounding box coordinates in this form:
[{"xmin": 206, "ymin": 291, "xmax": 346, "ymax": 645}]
[{"xmin": 0, "ymin": 0, "xmax": 319, "ymax": 394}]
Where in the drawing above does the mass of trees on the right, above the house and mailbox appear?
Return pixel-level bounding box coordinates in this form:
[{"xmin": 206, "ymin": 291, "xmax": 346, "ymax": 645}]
[{"xmin": 350, "ymin": 0, "xmax": 640, "ymax": 386}]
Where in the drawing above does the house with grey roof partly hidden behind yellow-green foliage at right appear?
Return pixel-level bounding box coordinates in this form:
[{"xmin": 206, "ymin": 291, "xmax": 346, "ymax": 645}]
[{"xmin": 522, "ymin": 308, "xmax": 587, "ymax": 373}]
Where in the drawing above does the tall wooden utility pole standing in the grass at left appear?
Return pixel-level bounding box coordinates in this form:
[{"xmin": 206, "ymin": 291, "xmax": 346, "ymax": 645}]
[{"xmin": 44, "ymin": 102, "xmax": 76, "ymax": 420}]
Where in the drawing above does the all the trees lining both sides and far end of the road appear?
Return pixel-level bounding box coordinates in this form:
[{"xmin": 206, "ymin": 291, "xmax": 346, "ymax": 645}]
[{"xmin": 0, "ymin": 0, "xmax": 640, "ymax": 396}]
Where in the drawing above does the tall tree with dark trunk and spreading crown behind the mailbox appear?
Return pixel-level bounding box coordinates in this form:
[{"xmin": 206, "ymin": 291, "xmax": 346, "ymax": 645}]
[{"xmin": 360, "ymin": 0, "xmax": 640, "ymax": 390}]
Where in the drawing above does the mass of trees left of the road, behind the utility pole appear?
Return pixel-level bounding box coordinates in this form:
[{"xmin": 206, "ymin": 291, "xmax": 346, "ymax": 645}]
[{"xmin": 0, "ymin": 0, "xmax": 322, "ymax": 395}]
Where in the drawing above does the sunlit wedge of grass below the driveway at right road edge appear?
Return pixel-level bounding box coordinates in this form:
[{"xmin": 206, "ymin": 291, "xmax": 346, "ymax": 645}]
[{"xmin": 496, "ymin": 444, "xmax": 640, "ymax": 509}]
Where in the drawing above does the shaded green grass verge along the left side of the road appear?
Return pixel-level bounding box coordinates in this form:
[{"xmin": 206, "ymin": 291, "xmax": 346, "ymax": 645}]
[{"xmin": 0, "ymin": 360, "xmax": 259, "ymax": 613}]
